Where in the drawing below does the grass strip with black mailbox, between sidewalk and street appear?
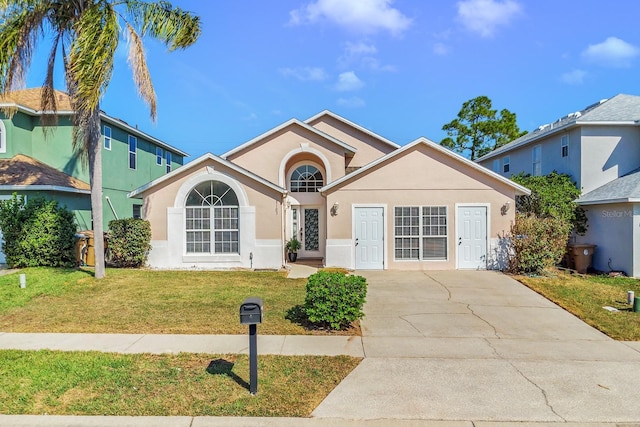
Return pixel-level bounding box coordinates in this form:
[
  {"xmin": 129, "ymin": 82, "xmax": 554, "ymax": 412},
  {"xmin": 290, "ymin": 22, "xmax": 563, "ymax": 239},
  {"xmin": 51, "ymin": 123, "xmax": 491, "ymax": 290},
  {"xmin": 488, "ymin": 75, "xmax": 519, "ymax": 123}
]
[{"xmin": 0, "ymin": 350, "xmax": 360, "ymax": 417}]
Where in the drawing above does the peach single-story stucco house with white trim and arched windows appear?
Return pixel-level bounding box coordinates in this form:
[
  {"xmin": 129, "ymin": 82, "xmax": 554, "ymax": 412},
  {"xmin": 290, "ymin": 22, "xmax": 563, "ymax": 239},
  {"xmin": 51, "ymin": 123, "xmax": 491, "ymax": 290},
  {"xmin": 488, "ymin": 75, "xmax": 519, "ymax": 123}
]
[{"xmin": 130, "ymin": 111, "xmax": 529, "ymax": 270}]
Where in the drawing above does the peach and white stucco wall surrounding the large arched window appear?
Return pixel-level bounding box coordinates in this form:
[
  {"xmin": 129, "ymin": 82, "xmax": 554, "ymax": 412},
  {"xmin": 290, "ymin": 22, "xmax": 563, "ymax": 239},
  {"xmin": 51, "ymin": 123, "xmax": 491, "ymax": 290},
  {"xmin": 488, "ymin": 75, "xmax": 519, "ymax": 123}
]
[{"xmin": 143, "ymin": 161, "xmax": 283, "ymax": 269}]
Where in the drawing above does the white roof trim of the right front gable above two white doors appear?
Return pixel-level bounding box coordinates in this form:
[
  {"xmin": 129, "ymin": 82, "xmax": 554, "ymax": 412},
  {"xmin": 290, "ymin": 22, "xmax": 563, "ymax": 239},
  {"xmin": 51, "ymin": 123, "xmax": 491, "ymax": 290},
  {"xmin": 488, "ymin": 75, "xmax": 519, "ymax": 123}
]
[{"xmin": 320, "ymin": 137, "xmax": 531, "ymax": 195}]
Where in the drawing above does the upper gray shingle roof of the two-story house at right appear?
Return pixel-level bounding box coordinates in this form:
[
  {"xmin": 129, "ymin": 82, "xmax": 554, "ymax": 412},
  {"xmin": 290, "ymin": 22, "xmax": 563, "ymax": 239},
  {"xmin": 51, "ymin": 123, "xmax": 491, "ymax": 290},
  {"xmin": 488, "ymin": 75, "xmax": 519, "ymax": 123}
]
[{"xmin": 476, "ymin": 94, "xmax": 640, "ymax": 162}]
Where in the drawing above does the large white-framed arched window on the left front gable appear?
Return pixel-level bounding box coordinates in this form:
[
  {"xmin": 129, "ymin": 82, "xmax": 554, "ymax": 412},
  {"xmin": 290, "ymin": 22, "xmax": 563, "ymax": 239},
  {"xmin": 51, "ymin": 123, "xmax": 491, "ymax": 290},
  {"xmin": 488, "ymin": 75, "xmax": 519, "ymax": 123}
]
[{"xmin": 186, "ymin": 181, "xmax": 240, "ymax": 254}]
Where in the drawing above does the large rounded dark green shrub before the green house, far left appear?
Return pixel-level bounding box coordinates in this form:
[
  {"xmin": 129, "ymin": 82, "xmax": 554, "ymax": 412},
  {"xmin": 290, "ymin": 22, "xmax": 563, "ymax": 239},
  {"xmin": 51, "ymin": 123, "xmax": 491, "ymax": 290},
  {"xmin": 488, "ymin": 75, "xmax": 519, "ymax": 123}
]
[{"xmin": 0, "ymin": 194, "xmax": 76, "ymax": 268}]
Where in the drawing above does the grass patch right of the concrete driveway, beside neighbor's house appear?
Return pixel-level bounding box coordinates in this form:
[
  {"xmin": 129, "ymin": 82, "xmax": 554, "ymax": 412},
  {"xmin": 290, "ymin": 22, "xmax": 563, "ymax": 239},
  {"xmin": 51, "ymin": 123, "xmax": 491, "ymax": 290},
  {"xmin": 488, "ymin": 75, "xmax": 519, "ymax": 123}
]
[{"xmin": 516, "ymin": 272, "xmax": 640, "ymax": 341}]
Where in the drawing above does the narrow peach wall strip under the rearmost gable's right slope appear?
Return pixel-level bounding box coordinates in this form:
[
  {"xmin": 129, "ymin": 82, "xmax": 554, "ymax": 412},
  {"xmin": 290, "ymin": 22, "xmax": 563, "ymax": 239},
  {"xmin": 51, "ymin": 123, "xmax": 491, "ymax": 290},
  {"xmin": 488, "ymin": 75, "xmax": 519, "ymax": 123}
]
[{"xmin": 309, "ymin": 116, "xmax": 395, "ymax": 167}]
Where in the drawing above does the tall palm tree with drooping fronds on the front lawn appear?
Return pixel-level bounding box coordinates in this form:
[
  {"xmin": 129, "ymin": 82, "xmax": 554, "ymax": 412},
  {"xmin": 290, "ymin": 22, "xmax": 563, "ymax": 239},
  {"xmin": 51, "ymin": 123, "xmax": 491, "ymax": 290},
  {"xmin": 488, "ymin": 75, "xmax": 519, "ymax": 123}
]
[{"xmin": 0, "ymin": 0, "xmax": 201, "ymax": 278}]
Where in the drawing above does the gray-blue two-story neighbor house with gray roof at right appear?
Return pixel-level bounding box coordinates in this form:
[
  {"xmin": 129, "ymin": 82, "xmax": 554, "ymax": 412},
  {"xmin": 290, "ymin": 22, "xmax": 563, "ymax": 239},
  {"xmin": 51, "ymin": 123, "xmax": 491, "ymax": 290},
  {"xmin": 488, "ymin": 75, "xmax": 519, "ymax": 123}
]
[{"xmin": 477, "ymin": 94, "xmax": 640, "ymax": 277}]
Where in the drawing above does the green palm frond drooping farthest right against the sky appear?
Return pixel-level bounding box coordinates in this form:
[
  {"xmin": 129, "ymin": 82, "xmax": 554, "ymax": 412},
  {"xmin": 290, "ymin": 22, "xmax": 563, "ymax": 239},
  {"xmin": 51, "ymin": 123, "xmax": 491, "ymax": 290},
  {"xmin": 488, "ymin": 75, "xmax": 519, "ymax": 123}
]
[{"xmin": 124, "ymin": 0, "xmax": 202, "ymax": 50}]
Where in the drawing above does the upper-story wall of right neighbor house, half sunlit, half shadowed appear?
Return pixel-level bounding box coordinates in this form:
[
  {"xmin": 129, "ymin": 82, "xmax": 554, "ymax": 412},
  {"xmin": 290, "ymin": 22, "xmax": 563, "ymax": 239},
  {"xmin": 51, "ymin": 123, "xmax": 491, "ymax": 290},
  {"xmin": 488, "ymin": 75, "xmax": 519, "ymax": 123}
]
[{"xmin": 581, "ymin": 126, "xmax": 640, "ymax": 193}]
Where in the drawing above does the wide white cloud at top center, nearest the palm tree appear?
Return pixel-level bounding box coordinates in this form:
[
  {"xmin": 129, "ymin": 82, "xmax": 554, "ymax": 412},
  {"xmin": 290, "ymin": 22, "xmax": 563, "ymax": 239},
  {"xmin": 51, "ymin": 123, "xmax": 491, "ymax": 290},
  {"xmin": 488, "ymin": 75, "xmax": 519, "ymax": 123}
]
[{"xmin": 289, "ymin": 0, "xmax": 411, "ymax": 35}]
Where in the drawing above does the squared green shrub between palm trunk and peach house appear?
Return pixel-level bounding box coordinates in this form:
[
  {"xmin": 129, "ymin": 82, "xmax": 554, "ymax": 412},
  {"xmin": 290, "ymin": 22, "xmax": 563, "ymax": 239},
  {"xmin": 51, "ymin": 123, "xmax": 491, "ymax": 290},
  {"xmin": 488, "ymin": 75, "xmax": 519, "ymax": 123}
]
[{"xmin": 108, "ymin": 218, "xmax": 151, "ymax": 267}]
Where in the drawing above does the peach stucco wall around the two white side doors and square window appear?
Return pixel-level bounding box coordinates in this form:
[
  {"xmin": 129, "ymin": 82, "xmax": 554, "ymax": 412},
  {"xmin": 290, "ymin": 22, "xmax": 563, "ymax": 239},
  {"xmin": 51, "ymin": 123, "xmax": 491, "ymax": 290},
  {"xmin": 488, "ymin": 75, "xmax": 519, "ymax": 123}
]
[{"xmin": 326, "ymin": 146, "xmax": 515, "ymax": 270}]
